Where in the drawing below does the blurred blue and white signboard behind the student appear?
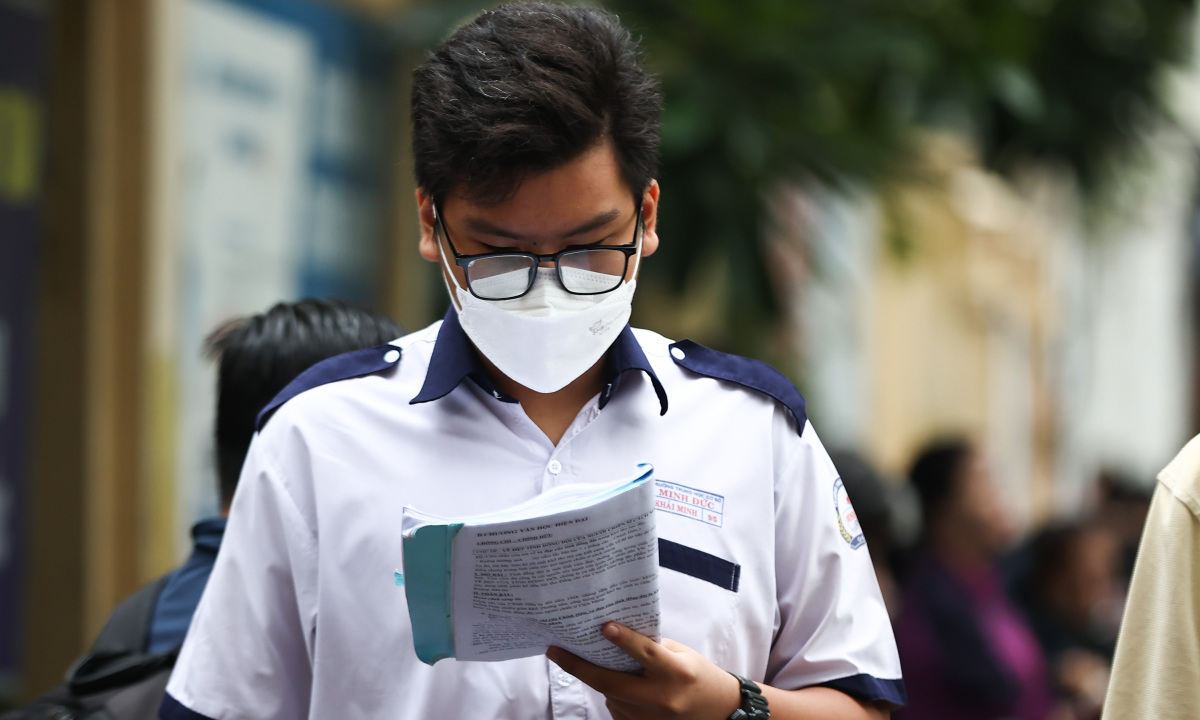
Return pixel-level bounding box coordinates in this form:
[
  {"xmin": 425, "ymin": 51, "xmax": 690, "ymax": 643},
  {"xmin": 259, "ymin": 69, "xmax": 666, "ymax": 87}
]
[{"xmin": 174, "ymin": 0, "xmax": 401, "ymax": 535}]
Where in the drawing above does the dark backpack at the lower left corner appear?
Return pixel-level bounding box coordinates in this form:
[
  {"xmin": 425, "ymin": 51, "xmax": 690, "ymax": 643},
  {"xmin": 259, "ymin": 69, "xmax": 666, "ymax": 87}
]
[{"xmin": 0, "ymin": 575, "xmax": 179, "ymax": 720}]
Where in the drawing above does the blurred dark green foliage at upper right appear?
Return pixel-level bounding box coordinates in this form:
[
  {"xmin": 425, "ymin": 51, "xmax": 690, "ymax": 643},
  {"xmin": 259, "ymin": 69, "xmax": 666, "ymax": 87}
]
[{"xmin": 605, "ymin": 0, "xmax": 1194, "ymax": 353}]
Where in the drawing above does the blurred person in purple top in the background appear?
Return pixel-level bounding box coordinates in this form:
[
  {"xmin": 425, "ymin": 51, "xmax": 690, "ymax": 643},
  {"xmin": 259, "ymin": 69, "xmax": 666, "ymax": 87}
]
[{"xmin": 895, "ymin": 439, "xmax": 1051, "ymax": 720}]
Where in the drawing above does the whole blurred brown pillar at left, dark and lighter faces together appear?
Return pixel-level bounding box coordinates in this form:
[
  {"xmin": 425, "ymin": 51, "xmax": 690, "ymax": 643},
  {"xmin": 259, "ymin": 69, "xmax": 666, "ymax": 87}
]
[{"xmin": 23, "ymin": 0, "xmax": 146, "ymax": 696}]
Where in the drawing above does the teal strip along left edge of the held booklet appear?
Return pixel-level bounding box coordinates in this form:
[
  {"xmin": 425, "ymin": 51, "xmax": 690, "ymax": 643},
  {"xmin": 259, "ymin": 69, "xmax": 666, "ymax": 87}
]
[{"xmin": 403, "ymin": 523, "xmax": 462, "ymax": 665}]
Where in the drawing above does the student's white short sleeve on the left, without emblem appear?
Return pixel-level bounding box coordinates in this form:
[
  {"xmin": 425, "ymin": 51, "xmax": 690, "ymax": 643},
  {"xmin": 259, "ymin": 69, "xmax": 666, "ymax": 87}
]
[{"xmin": 160, "ymin": 438, "xmax": 317, "ymax": 720}]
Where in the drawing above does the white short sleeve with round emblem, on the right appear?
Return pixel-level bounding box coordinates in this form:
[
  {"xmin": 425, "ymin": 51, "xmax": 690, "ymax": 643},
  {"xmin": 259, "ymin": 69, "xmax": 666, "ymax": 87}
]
[{"xmin": 766, "ymin": 425, "xmax": 906, "ymax": 706}]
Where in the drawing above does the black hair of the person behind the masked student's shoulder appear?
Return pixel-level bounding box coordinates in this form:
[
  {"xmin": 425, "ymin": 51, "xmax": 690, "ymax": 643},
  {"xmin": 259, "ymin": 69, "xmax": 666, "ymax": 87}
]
[{"xmin": 204, "ymin": 299, "xmax": 404, "ymax": 505}]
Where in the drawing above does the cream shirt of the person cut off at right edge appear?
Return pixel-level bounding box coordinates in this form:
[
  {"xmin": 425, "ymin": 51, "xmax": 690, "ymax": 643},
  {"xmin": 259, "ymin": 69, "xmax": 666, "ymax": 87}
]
[{"xmin": 1104, "ymin": 438, "xmax": 1200, "ymax": 720}]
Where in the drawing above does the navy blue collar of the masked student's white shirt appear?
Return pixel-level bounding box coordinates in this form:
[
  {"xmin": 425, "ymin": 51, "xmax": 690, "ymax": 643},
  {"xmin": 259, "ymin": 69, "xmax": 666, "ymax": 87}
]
[{"xmin": 409, "ymin": 305, "xmax": 667, "ymax": 415}]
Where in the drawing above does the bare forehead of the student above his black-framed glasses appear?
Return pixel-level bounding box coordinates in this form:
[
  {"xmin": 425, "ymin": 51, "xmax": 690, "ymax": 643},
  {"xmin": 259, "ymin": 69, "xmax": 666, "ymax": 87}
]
[{"xmin": 442, "ymin": 140, "xmax": 634, "ymax": 227}]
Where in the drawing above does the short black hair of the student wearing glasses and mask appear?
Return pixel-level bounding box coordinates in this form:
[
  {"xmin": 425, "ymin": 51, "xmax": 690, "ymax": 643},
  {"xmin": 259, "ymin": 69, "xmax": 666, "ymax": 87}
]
[{"xmin": 412, "ymin": 2, "xmax": 662, "ymax": 204}]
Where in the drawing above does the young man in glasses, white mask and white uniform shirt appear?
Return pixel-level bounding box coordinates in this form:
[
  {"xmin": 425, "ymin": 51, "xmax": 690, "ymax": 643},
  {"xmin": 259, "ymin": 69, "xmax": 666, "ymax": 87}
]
[{"xmin": 163, "ymin": 2, "xmax": 904, "ymax": 720}]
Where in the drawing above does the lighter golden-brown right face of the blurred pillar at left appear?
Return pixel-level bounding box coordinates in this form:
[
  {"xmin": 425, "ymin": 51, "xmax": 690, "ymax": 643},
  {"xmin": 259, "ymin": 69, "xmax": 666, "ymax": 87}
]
[{"xmin": 84, "ymin": 0, "xmax": 148, "ymax": 636}]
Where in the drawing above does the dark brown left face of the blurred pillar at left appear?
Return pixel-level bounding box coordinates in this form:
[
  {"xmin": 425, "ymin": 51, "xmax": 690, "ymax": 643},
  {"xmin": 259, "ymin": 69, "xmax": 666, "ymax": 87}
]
[{"xmin": 22, "ymin": 0, "xmax": 88, "ymax": 696}]
